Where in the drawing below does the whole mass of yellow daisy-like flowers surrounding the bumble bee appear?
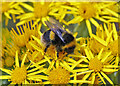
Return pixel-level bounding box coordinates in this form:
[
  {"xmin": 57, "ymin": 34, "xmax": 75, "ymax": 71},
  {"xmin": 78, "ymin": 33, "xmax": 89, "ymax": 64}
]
[{"xmin": 0, "ymin": 0, "xmax": 120, "ymax": 85}]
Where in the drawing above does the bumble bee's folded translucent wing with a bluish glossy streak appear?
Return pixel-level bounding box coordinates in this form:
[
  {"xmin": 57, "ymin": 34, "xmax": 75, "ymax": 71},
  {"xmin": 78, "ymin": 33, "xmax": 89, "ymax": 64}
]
[{"xmin": 45, "ymin": 21, "xmax": 65, "ymax": 43}]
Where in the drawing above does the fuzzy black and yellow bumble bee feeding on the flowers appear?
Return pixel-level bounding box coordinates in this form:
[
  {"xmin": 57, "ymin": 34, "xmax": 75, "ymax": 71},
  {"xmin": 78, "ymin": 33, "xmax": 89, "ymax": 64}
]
[{"xmin": 41, "ymin": 17, "xmax": 76, "ymax": 54}]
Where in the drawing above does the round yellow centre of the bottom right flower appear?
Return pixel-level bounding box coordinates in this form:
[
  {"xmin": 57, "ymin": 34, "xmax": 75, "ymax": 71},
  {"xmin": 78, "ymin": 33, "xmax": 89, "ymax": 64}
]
[{"xmin": 89, "ymin": 57, "xmax": 103, "ymax": 72}]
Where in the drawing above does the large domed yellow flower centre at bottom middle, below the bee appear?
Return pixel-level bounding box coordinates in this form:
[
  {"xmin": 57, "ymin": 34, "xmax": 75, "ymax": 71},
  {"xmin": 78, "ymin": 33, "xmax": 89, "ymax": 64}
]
[{"xmin": 48, "ymin": 67, "xmax": 70, "ymax": 84}]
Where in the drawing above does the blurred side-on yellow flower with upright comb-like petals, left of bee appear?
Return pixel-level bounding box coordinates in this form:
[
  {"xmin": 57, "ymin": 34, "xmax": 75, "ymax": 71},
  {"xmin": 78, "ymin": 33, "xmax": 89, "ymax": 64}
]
[{"xmin": 9, "ymin": 21, "xmax": 39, "ymax": 59}]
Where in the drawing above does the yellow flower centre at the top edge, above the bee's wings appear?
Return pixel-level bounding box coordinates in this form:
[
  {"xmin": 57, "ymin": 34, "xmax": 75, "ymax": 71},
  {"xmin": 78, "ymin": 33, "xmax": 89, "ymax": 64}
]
[{"xmin": 34, "ymin": 2, "xmax": 50, "ymax": 18}]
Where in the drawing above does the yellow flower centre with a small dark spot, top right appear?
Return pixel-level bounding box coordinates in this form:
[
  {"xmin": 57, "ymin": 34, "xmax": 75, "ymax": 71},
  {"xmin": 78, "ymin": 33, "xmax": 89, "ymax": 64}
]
[{"xmin": 79, "ymin": 2, "xmax": 97, "ymax": 19}]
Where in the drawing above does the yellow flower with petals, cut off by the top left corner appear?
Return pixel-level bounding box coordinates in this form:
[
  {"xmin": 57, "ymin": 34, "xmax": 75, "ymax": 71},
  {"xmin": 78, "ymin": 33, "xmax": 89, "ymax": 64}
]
[{"xmin": 2, "ymin": 2, "xmax": 24, "ymax": 25}]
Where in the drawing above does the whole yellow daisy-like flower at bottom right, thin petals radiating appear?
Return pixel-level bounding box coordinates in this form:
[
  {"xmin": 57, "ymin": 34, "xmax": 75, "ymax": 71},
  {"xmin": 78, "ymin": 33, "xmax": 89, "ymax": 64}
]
[{"xmin": 71, "ymin": 47, "xmax": 119, "ymax": 84}]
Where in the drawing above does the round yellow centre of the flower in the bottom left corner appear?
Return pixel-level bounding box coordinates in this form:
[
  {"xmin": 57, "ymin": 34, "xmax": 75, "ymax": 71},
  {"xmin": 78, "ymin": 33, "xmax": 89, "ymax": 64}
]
[{"xmin": 11, "ymin": 67, "xmax": 27, "ymax": 84}]
